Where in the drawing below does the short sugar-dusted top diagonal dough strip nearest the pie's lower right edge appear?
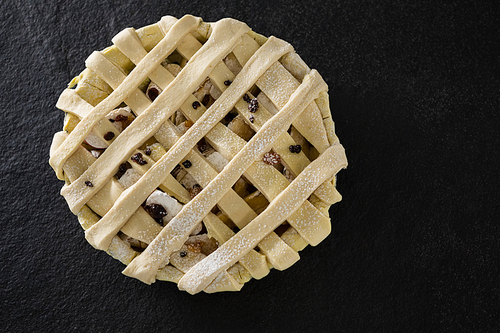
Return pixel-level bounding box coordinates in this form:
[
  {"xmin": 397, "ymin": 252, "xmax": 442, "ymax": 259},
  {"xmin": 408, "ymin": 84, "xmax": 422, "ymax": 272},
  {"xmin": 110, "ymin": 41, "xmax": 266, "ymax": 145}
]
[{"xmin": 179, "ymin": 144, "xmax": 347, "ymax": 294}]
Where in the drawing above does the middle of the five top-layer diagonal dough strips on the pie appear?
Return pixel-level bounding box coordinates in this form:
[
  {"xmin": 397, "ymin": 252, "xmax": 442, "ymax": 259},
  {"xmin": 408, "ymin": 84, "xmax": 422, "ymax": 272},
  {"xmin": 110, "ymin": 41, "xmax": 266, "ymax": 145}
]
[{"xmin": 85, "ymin": 38, "xmax": 291, "ymax": 250}]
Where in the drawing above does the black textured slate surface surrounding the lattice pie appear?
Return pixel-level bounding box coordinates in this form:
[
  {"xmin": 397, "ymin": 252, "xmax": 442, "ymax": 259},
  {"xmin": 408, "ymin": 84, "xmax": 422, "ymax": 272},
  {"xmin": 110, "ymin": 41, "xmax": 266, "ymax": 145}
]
[{"xmin": 0, "ymin": 0, "xmax": 500, "ymax": 332}]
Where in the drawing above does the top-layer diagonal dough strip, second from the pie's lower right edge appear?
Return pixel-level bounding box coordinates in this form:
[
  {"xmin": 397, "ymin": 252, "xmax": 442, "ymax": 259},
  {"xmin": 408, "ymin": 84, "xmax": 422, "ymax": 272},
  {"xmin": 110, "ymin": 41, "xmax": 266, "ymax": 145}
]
[{"xmin": 122, "ymin": 70, "xmax": 327, "ymax": 284}]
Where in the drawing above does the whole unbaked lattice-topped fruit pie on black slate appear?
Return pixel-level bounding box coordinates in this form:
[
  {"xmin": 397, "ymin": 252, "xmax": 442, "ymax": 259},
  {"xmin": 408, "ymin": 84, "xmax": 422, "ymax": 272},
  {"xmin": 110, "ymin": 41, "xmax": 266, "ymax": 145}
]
[{"xmin": 50, "ymin": 15, "xmax": 347, "ymax": 294}]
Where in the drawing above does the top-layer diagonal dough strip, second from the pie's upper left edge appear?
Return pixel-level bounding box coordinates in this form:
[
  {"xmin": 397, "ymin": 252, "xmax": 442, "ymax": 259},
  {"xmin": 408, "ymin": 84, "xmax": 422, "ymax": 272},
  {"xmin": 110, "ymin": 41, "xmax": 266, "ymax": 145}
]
[{"xmin": 57, "ymin": 16, "xmax": 248, "ymax": 211}]
